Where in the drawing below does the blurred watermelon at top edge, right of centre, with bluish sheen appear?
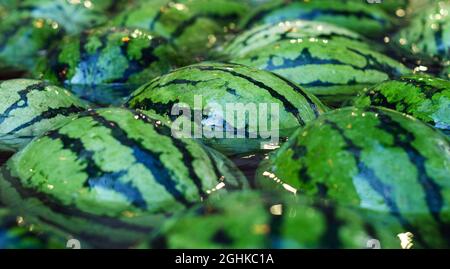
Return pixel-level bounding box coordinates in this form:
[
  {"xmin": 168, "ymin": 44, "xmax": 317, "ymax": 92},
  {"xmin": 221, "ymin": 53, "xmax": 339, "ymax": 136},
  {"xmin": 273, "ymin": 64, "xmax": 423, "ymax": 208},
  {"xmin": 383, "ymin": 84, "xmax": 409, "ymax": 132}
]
[{"xmin": 240, "ymin": 0, "xmax": 396, "ymax": 37}]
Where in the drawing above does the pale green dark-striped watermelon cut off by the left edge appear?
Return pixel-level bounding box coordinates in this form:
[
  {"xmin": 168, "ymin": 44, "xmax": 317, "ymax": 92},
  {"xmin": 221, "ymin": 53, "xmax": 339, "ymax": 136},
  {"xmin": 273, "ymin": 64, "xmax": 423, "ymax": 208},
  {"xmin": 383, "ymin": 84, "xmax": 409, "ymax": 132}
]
[{"xmin": 0, "ymin": 79, "xmax": 87, "ymax": 151}]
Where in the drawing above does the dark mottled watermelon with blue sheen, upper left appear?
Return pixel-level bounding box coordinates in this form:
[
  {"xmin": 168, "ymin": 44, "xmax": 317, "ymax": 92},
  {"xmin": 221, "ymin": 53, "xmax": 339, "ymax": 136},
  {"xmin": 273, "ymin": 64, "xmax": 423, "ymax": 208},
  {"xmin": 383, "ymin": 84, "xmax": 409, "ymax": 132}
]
[{"xmin": 35, "ymin": 27, "xmax": 178, "ymax": 105}]
